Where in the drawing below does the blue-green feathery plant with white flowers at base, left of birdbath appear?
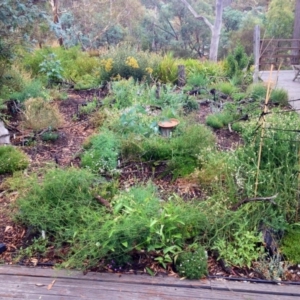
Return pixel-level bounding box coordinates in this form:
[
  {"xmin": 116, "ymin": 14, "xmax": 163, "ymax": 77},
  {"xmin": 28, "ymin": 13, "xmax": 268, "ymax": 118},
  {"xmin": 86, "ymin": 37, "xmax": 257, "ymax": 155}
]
[{"xmin": 81, "ymin": 130, "xmax": 120, "ymax": 174}]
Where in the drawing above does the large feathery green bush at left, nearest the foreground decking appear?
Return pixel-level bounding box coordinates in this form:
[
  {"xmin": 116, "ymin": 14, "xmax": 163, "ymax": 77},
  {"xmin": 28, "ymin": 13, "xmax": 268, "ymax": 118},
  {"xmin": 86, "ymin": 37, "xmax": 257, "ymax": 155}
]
[{"xmin": 16, "ymin": 168, "xmax": 96, "ymax": 234}]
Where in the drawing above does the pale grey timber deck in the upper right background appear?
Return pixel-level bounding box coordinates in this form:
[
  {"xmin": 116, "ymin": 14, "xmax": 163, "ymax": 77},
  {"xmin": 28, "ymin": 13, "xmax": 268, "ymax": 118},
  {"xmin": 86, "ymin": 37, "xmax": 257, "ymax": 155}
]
[{"xmin": 260, "ymin": 70, "xmax": 300, "ymax": 109}]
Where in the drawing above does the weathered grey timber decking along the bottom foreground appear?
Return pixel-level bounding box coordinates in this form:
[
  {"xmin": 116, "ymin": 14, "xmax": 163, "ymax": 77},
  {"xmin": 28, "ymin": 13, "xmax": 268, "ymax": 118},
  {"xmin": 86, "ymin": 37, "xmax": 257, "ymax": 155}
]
[{"xmin": 0, "ymin": 265, "xmax": 300, "ymax": 300}]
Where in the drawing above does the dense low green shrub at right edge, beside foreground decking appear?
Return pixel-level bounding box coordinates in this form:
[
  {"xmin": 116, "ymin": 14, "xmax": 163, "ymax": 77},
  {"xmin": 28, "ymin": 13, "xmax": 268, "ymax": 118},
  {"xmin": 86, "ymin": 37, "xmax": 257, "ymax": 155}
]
[{"xmin": 280, "ymin": 226, "xmax": 300, "ymax": 264}]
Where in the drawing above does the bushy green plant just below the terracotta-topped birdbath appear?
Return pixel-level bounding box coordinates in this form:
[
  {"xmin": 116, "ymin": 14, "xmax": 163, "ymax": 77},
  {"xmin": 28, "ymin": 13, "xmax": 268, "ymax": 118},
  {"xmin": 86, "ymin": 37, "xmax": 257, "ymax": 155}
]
[{"xmin": 122, "ymin": 124, "xmax": 214, "ymax": 177}]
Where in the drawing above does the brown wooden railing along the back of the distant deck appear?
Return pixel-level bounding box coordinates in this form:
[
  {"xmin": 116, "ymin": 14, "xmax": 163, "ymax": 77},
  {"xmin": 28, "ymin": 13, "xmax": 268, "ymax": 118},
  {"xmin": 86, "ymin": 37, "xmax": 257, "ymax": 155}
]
[{"xmin": 259, "ymin": 39, "xmax": 300, "ymax": 69}]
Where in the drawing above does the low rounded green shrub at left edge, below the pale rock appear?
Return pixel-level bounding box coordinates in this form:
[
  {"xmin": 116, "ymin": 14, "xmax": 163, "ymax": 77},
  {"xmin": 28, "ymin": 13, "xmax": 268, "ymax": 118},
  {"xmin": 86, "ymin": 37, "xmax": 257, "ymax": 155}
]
[{"xmin": 0, "ymin": 146, "xmax": 29, "ymax": 174}]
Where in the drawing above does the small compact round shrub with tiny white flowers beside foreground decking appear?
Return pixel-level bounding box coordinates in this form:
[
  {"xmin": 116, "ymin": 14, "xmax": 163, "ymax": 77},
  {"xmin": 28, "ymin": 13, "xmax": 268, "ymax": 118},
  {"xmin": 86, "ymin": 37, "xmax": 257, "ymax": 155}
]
[{"xmin": 176, "ymin": 246, "xmax": 208, "ymax": 279}]
